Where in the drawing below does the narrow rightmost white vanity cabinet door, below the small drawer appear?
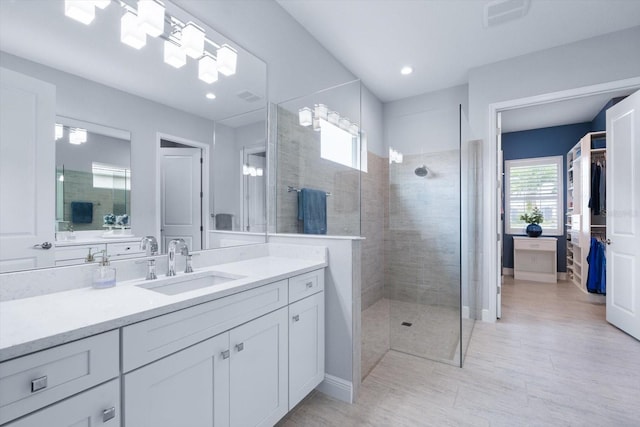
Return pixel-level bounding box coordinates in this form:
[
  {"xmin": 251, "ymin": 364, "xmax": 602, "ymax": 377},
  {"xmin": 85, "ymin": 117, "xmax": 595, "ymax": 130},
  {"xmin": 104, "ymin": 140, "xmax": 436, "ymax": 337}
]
[{"xmin": 289, "ymin": 292, "xmax": 324, "ymax": 410}]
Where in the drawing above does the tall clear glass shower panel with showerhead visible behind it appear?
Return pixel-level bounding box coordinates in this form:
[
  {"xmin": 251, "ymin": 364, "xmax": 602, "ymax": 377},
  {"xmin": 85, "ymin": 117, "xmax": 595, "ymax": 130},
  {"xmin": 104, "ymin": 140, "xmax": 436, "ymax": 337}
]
[{"xmin": 385, "ymin": 107, "xmax": 461, "ymax": 365}]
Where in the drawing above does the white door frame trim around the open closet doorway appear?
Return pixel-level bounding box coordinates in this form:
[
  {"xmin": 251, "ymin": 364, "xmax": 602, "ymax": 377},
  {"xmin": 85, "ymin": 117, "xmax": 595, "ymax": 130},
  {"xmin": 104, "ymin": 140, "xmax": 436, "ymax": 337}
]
[{"xmin": 485, "ymin": 78, "xmax": 640, "ymax": 320}]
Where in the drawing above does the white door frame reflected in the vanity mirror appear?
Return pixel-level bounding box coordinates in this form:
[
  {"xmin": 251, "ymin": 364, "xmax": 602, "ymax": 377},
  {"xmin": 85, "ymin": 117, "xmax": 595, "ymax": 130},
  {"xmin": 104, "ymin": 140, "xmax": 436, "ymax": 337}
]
[{"xmin": 154, "ymin": 132, "xmax": 210, "ymax": 250}]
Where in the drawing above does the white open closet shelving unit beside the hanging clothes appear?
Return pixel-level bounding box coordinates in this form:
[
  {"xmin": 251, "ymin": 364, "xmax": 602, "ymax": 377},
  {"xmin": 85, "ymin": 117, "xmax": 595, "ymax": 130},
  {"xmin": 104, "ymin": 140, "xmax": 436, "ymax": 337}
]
[{"xmin": 565, "ymin": 132, "xmax": 606, "ymax": 293}]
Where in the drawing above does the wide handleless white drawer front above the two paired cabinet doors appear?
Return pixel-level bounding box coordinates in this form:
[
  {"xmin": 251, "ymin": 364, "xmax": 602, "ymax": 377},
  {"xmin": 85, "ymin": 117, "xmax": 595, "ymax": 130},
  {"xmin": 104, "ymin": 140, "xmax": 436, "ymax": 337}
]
[{"xmin": 122, "ymin": 280, "xmax": 287, "ymax": 372}]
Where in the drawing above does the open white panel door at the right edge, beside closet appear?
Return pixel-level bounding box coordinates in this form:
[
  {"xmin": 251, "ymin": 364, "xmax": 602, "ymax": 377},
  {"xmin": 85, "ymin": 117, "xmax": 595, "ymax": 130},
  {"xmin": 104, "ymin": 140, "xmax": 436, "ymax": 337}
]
[{"xmin": 606, "ymin": 91, "xmax": 640, "ymax": 339}]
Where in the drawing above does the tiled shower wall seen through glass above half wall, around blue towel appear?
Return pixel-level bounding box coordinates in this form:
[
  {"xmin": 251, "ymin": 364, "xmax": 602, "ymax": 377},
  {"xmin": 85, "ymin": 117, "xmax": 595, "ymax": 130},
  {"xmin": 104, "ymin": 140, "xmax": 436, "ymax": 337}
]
[{"xmin": 276, "ymin": 108, "xmax": 360, "ymax": 236}]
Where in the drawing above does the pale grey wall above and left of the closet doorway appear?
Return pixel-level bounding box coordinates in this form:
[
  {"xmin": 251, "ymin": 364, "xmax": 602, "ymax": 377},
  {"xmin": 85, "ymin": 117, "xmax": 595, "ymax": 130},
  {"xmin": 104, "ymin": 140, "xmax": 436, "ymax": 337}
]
[{"xmin": 469, "ymin": 26, "xmax": 640, "ymax": 320}]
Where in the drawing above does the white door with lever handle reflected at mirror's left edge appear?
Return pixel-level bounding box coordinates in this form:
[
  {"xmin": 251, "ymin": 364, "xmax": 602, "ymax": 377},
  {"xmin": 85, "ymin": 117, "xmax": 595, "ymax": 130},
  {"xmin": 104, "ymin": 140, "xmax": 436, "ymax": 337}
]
[{"xmin": 0, "ymin": 68, "xmax": 56, "ymax": 272}]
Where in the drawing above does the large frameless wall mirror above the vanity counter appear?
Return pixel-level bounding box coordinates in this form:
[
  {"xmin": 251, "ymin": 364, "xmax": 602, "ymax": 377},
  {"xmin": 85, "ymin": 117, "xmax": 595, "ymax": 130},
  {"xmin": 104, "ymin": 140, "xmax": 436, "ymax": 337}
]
[{"xmin": 0, "ymin": 0, "xmax": 267, "ymax": 272}]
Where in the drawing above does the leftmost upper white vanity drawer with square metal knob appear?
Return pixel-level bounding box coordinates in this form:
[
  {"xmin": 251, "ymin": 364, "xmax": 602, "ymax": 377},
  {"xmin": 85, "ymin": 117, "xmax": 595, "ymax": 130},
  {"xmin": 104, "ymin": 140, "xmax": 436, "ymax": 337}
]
[{"xmin": 0, "ymin": 331, "xmax": 120, "ymax": 424}]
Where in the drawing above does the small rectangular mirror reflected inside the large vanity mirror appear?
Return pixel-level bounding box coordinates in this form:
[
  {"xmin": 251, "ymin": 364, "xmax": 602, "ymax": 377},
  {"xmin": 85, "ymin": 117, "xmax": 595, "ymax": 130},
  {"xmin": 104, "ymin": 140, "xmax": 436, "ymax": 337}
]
[{"xmin": 56, "ymin": 117, "xmax": 131, "ymax": 237}]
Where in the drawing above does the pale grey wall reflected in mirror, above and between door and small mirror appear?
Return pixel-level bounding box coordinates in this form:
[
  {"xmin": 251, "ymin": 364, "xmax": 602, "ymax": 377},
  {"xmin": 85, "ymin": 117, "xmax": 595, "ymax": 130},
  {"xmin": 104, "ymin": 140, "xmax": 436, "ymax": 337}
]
[{"xmin": 0, "ymin": 53, "xmax": 213, "ymax": 236}]
